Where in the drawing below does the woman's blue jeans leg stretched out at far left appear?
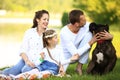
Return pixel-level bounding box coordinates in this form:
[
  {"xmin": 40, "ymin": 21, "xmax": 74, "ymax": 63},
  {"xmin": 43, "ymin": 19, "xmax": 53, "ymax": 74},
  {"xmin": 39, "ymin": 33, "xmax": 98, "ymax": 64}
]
[{"xmin": 3, "ymin": 59, "xmax": 25, "ymax": 75}]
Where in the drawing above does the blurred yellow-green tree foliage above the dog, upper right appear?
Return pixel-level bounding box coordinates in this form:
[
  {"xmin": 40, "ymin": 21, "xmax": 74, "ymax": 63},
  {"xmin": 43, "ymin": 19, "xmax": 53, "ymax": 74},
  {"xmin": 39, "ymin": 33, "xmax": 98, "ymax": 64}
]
[{"xmin": 73, "ymin": 0, "xmax": 120, "ymax": 24}]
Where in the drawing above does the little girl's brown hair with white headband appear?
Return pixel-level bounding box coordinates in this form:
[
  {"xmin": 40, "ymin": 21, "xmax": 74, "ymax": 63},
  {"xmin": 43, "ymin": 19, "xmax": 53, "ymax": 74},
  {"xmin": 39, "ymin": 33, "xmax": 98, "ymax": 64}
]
[{"xmin": 43, "ymin": 29, "xmax": 57, "ymax": 47}]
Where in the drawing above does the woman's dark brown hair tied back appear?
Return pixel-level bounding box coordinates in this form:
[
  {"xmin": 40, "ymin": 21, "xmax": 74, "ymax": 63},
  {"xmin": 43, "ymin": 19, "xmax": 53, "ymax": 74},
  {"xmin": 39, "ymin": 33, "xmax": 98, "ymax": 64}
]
[{"xmin": 32, "ymin": 10, "xmax": 49, "ymax": 28}]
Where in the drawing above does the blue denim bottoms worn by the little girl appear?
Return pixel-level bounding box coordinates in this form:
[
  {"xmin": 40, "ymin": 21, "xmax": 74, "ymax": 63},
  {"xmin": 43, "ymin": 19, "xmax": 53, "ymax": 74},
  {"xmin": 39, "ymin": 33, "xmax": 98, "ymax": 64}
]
[{"xmin": 37, "ymin": 60, "xmax": 59, "ymax": 75}]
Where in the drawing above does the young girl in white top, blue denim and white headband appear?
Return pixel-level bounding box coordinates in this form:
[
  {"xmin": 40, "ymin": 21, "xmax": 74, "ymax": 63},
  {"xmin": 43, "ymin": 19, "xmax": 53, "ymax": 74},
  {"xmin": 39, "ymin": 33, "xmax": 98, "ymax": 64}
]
[{"xmin": 40, "ymin": 29, "xmax": 78, "ymax": 75}]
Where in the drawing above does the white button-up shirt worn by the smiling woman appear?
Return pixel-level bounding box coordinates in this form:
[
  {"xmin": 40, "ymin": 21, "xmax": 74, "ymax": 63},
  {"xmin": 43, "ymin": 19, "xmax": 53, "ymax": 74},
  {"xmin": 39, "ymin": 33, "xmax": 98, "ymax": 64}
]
[{"xmin": 19, "ymin": 28, "xmax": 43, "ymax": 65}]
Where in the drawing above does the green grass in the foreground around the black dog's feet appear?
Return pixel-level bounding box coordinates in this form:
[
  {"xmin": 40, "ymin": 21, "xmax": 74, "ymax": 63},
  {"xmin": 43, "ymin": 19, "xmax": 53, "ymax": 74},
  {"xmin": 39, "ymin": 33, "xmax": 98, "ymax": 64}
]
[{"xmin": 1, "ymin": 59, "xmax": 120, "ymax": 80}]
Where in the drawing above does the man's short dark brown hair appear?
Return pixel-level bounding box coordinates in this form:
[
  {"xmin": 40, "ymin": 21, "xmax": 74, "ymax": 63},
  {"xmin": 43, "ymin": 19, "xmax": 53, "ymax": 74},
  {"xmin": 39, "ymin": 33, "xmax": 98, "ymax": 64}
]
[{"xmin": 69, "ymin": 10, "xmax": 84, "ymax": 24}]
